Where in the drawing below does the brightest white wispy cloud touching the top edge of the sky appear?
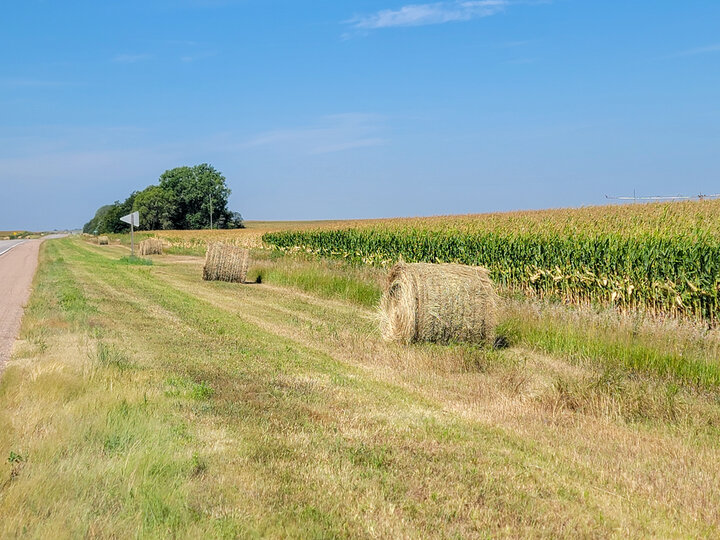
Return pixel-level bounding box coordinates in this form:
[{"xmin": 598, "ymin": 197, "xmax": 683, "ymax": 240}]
[{"xmin": 346, "ymin": 0, "xmax": 510, "ymax": 30}]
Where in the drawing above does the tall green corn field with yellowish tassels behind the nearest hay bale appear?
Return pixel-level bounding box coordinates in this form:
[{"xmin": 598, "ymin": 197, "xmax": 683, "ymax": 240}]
[{"xmin": 263, "ymin": 201, "xmax": 720, "ymax": 324}]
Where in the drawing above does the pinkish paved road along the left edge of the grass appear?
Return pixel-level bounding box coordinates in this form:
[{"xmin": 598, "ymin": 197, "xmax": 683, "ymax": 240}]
[{"xmin": 0, "ymin": 240, "xmax": 48, "ymax": 372}]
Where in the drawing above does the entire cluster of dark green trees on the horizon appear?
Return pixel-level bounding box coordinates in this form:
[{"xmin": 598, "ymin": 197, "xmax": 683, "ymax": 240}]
[{"xmin": 83, "ymin": 163, "xmax": 244, "ymax": 234}]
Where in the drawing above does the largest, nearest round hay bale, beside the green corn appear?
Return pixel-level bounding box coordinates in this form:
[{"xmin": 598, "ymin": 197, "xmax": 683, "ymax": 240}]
[{"xmin": 380, "ymin": 262, "xmax": 499, "ymax": 344}]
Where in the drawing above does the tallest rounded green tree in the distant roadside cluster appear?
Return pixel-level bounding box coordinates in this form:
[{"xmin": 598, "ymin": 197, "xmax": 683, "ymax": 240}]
[{"xmin": 160, "ymin": 163, "xmax": 232, "ymax": 229}]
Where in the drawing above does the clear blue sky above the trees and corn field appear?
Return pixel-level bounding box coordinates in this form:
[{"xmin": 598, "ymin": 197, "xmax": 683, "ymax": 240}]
[{"xmin": 0, "ymin": 0, "xmax": 720, "ymax": 230}]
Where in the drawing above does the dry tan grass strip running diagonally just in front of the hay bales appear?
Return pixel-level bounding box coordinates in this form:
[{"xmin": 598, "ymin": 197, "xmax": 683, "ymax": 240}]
[{"xmin": 149, "ymin": 252, "xmax": 720, "ymax": 530}]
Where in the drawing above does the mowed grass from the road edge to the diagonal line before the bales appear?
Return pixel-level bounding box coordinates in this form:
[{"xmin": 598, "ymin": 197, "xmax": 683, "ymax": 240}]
[{"xmin": 0, "ymin": 239, "xmax": 717, "ymax": 537}]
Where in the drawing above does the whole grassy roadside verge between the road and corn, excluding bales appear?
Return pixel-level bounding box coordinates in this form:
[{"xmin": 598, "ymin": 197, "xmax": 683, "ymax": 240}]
[{"xmin": 0, "ymin": 238, "xmax": 720, "ymax": 538}]
